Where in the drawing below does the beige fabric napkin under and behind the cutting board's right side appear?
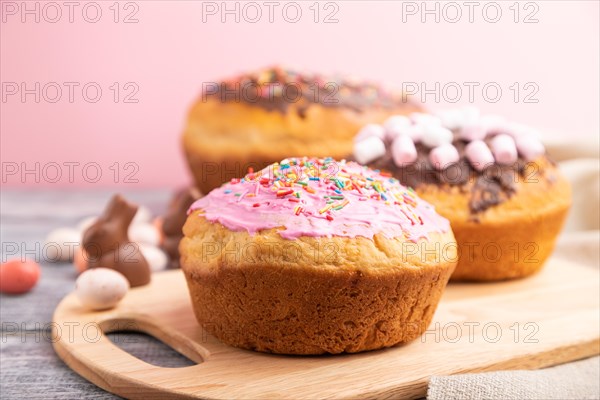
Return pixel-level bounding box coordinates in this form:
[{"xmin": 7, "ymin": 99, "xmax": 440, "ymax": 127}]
[{"xmin": 427, "ymin": 142, "xmax": 600, "ymax": 400}]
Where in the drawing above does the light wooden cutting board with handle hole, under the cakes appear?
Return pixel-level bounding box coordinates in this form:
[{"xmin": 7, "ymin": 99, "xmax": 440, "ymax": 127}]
[{"xmin": 53, "ymin": 259, "xmax": 600, "ymax": 399}]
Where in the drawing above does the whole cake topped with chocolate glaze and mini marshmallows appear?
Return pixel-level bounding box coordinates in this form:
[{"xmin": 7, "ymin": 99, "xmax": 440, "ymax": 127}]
[{"xmin": 354, "ymin": 108, "xmax": 571, "ymax": 281}]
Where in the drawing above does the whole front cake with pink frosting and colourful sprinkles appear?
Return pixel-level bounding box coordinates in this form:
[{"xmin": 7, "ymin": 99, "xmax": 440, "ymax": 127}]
[{"xmin": 180, "ymin": 158, "xmax": 457, "ymax": 354}]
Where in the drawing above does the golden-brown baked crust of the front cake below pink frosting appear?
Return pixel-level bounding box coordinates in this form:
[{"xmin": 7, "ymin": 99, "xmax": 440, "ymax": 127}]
[{"xmin": 181, "ymin": 216, "xmax": 457, "ymax": 354}]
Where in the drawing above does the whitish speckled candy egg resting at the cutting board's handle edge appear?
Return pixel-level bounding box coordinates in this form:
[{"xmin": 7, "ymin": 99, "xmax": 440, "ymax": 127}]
[{"xmin": 75, "ymin": 268, "xmax": 129, "ymax": 310}]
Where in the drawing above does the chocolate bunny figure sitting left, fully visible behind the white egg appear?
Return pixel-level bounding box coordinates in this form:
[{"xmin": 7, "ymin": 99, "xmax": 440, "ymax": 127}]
[{"xmin": 82, "ymin": 194, "xmax": 151, "ymax": 287}]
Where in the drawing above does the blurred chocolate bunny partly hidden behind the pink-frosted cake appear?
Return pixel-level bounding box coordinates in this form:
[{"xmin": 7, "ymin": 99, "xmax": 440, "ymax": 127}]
[{"xmin": 161, "ymin": 187, "xmax": 202, "ymax": 268}]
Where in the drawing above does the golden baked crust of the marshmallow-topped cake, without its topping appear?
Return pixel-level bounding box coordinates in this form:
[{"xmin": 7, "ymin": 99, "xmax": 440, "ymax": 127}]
[{"xmin": 417, "ymin": 157, "xmax": 571, "ymax": 281}]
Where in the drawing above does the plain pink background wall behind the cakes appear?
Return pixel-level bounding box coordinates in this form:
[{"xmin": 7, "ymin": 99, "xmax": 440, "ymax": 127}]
[{"xmin": 0, "ymin": 1, "xmax": 600, "ymax": 188}]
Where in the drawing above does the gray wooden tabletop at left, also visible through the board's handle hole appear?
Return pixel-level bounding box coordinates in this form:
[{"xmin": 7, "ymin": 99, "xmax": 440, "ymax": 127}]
[{"xmin": 0, "ymin": 189, "xmax": 192, "ymax": 399}]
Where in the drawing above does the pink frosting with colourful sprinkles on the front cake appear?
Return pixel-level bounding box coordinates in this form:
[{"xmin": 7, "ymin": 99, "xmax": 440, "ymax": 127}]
[{"xmin": 188, "ymin": 158, "xmax": 450, "ymax": 242}]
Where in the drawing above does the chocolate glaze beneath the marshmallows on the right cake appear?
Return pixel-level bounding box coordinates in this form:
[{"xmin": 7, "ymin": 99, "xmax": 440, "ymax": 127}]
[{"xmin": 369, "ymin": 134, "xmax": 553, "ymax": 219}]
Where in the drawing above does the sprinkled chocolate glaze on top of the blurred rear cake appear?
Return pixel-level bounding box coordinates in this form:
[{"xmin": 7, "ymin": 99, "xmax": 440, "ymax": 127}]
[{"xmin": 203, "ymin": 67, "xmax": 415, "ymax": 118}]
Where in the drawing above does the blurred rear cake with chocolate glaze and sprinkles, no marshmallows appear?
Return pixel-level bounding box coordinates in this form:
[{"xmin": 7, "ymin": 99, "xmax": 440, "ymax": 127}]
[{"xmin": 183, "ymin": 67, "xmax": 418, "ymax": 193}]
